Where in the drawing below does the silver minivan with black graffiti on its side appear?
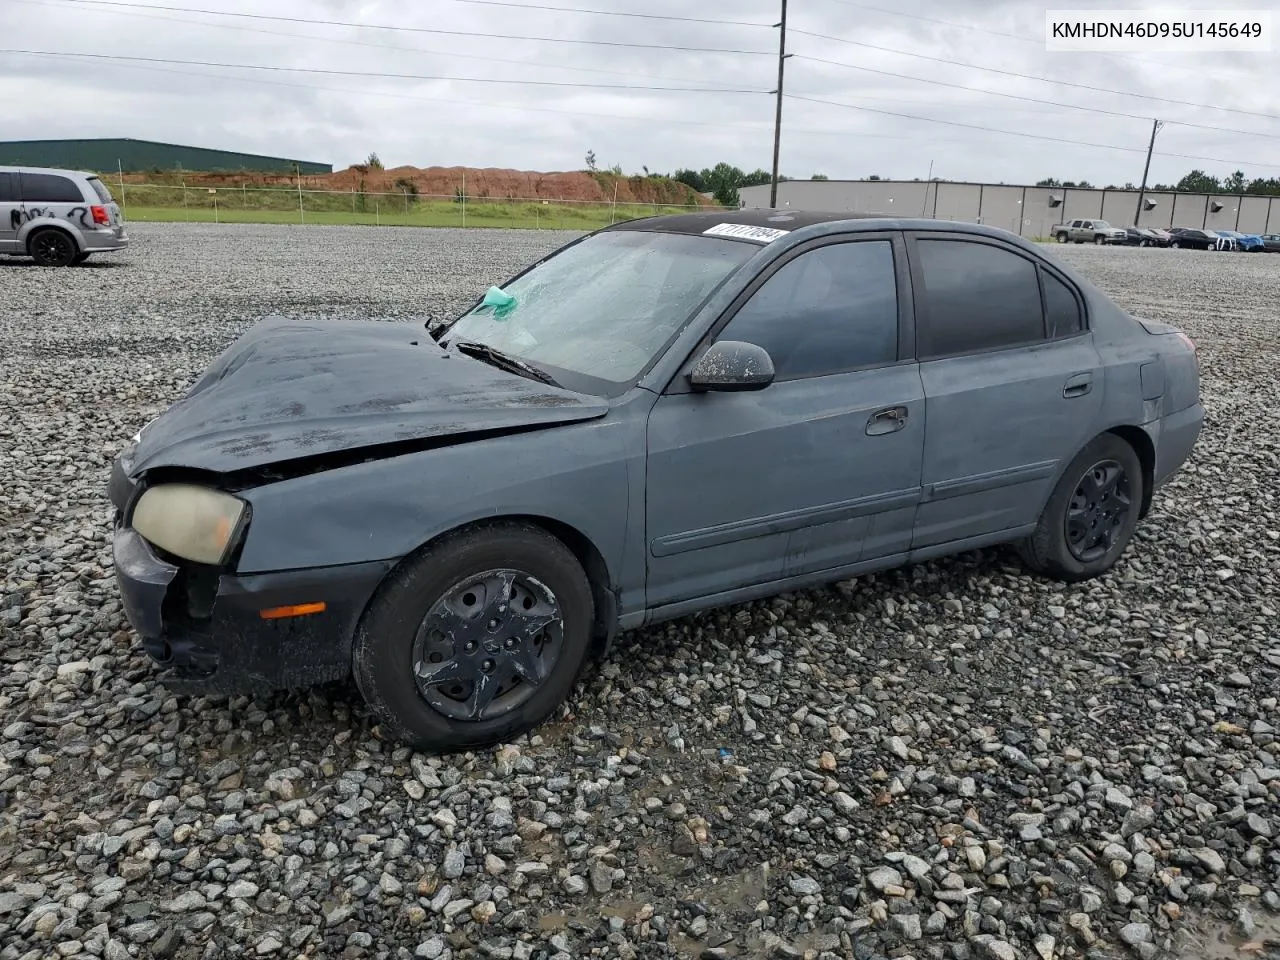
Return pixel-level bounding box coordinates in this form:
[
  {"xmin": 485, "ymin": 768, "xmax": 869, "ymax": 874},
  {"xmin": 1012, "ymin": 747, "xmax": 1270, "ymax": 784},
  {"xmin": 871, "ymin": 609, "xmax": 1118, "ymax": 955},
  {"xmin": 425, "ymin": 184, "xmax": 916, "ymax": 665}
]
[{"xmin": 0, "ymin": 166, "xmax": 129, "ymax": 266}]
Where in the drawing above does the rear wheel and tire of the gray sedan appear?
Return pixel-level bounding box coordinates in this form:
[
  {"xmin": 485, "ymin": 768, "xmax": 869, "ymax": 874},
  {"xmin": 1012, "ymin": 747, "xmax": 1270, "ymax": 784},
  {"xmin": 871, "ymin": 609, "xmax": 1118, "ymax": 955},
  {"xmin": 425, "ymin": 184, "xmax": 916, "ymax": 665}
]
[{"xmin": 1018, "ymin": 434, "xmax": 1144, "ymax": 582}]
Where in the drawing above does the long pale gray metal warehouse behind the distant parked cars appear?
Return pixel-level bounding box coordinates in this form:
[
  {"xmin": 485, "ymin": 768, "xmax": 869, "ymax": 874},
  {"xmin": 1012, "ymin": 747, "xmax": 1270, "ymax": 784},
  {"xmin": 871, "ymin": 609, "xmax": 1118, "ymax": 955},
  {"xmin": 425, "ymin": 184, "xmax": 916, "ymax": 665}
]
[{"xmin": 739, "ymin": 180, "xmax": 1280, "ymax": 238}]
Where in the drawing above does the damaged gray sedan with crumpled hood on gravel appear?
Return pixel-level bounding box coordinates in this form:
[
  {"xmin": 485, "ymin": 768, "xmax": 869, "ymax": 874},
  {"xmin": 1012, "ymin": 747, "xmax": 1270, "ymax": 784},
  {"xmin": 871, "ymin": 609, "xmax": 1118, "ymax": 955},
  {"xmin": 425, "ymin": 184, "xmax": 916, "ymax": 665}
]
[{"xmin": 110, "ymin": 211, "xmax": 1203, "ymax": 750}]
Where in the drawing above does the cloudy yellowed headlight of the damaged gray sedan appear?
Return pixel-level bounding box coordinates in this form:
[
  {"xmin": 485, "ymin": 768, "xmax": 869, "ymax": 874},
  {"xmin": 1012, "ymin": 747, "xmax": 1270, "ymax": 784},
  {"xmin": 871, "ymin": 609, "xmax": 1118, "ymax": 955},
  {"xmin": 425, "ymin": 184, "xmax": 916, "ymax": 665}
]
[{"xmin": 133, "ymin": 484, "xmax": 248, "ymax": 566}]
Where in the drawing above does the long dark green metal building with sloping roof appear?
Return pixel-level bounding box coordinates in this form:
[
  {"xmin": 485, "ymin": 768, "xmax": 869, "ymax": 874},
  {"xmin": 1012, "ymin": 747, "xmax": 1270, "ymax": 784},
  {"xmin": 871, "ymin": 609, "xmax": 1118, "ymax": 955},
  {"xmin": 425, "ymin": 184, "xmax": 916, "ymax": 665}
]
[{"xmin": 0, "ymin": 138, "xmax": 333, "ymax": 174}]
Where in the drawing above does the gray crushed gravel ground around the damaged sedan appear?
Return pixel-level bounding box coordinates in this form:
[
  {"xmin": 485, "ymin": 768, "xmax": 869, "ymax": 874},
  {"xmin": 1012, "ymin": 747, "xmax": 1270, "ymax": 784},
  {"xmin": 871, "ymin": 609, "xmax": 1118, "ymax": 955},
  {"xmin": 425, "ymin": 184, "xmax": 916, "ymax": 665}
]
[{"xmin": 0, "ymin": 224, "xmax": 1280, "ymax": 960}]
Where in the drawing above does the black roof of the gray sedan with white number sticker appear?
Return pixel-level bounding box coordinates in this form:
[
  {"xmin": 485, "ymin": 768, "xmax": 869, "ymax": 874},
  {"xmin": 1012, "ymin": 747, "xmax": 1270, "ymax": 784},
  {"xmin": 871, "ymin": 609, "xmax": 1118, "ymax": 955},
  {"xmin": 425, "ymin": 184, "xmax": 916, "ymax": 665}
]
[{"xmin": 600, "ymin": 209, "xmax": 1016, "ymax": 246}]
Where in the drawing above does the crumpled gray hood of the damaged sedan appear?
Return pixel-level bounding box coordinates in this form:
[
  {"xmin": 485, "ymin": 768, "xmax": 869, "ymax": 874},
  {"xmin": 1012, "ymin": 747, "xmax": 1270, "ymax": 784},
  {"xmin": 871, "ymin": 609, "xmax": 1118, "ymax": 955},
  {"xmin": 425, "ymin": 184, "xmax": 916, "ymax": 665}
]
[{"xmin": 129, "ymin": 317, "xmax": 608, "ymax": 476}]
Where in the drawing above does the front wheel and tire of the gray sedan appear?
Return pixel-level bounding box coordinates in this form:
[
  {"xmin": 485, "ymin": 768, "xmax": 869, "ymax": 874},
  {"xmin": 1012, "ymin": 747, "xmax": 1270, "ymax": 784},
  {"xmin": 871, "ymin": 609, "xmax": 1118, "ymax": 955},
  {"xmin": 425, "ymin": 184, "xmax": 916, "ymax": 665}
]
[{"xmin": 352, "ymin": 522, "xmax": 595, "ymax": 753}]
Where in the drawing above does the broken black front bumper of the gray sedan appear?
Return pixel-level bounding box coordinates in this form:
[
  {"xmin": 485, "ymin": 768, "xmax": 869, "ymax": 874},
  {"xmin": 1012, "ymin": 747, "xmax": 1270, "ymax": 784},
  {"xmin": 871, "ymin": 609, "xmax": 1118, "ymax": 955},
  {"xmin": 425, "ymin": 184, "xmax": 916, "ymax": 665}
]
[{"xmin": 110, "ymin": 462, "xmax": 394, "ymax": 695}]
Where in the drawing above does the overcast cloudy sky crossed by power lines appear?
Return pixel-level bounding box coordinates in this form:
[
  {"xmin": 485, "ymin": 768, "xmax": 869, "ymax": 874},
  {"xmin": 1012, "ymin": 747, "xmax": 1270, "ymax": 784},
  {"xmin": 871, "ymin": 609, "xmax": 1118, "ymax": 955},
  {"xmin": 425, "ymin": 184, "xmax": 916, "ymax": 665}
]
[{"xmin": 0, "ymin": 0, "xmax": 1280, "ymax": 186}]
